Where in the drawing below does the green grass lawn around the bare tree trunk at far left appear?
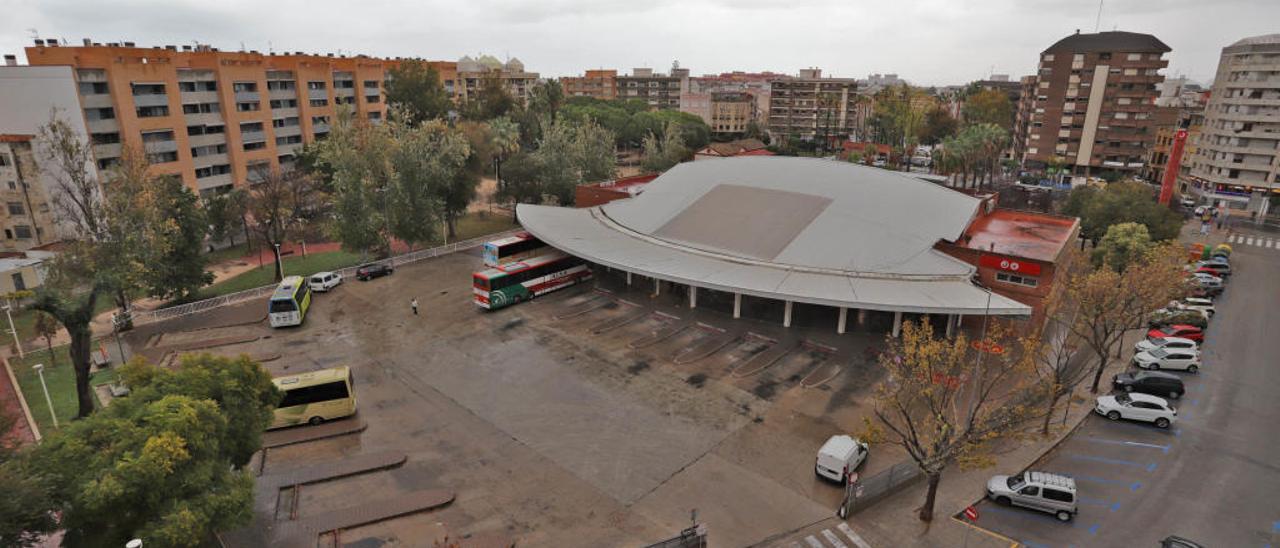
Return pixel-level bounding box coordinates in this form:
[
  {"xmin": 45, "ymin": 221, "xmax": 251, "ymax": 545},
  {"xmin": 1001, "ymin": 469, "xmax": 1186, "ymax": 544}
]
[{"xmin": 9, "ymin": 341, "xmax": 115, "ymax": 435}]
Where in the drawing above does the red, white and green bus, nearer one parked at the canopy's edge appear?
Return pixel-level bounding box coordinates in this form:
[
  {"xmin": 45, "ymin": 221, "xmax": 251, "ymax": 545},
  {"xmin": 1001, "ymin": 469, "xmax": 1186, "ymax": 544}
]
[{"xmin": 471, "ymin": 251, "xmax": 591, "ymax": 310}]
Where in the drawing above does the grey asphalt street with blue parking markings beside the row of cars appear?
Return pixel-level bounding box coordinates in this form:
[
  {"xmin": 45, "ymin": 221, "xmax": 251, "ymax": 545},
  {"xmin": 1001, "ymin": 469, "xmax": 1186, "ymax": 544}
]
[{"xmin": 978, "ymin": 227, "xmax": 1280, "ymax": 548}]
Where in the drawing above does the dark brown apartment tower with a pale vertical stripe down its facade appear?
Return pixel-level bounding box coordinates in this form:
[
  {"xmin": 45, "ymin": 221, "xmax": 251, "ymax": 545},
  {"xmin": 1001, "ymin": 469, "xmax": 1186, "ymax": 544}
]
[{"xmin": 1021, "ymin": 31, "xmax": 1170, "ymax": 177}]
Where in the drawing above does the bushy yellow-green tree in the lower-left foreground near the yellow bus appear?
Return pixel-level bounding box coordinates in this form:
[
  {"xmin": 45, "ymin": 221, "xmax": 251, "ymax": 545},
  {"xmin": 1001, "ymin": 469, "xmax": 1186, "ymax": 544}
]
[{"xmin": 29, "ymin": 355, "xmax": 279, "ymax": 547}]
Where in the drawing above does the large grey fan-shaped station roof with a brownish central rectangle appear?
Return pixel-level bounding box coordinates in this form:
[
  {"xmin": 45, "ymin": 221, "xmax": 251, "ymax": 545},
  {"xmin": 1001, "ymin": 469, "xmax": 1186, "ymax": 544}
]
[{"xmin": 517, "ymin": 156, "xmax": 1032, "ymax": 316}]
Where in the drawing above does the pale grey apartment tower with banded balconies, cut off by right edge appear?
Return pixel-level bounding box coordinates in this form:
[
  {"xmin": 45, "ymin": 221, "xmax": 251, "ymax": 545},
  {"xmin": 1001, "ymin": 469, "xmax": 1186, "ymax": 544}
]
[{"xmin": 1188, "ymin": 35, "xmax": 1280, "ymax": 219}]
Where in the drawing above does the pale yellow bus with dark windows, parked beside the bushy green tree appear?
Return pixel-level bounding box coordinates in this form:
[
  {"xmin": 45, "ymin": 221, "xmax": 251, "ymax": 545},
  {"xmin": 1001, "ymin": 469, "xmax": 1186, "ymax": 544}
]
[{"xmin": 268, "ymin": 366, "xmax": 356, "ymax": 429}]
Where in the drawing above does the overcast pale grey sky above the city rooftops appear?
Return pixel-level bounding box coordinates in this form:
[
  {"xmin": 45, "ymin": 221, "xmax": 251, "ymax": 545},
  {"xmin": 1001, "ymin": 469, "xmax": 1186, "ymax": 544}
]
[{"xmin": 0, "ymin": 0, "xmax": 1280, "ymax": 85}]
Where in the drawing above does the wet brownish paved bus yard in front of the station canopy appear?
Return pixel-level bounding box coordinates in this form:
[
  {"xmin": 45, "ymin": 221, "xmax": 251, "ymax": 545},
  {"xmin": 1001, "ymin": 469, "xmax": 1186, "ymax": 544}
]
[{"xmin": 129, "ymin": 245, "xmax": 901, "ymax": 547}]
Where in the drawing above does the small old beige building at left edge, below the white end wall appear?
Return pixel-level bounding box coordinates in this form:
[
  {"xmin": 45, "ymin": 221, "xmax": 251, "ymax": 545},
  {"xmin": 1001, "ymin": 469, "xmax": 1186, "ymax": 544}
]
[{"xmin": 0, "ymin": 133, "xmax": 58, "ymax": 251}]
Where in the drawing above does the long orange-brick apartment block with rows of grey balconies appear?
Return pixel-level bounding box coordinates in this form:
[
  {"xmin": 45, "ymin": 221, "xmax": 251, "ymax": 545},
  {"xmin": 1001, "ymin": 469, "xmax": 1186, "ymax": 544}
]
[{"xmin": 27, "ymin": 40, "xmax": 409, "ymax": 193}]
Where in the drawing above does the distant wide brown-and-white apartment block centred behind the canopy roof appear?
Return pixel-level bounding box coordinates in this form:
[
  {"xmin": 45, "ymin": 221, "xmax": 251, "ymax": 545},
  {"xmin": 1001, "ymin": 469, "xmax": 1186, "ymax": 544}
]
[{"xmin": 768, "ymin": 68, "xmax": 859, "ymax": 142}]
